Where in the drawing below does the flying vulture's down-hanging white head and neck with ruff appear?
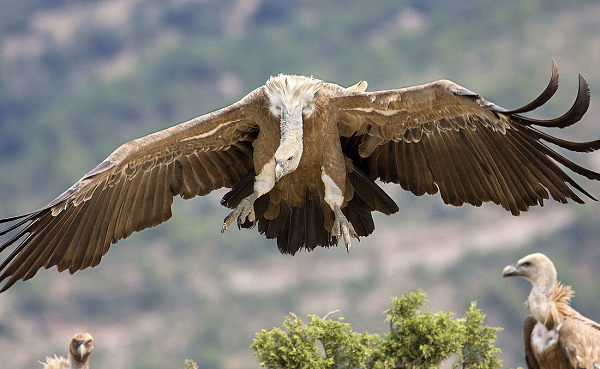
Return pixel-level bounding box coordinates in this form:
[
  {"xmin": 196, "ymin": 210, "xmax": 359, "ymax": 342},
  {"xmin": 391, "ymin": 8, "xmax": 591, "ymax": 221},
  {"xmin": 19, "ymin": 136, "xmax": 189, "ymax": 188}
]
[{"xmin": 265, "ymin": 74, "xmax": 323, "ymax": 181}]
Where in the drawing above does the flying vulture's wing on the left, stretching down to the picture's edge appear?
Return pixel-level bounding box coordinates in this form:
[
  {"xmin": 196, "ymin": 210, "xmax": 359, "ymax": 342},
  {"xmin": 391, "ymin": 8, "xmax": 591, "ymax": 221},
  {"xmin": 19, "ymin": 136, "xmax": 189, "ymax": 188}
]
[{"xmin": 0, "ymin": 88, "xmax": 264, "ymax": 292}]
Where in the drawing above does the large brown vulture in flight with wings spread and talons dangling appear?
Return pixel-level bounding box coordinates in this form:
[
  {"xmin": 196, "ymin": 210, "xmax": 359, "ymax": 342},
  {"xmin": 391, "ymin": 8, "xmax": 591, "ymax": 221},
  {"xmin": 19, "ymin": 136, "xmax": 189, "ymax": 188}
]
[{"xmin": 0, "ymin": 60, "xmax": 600, "ymax": 292}]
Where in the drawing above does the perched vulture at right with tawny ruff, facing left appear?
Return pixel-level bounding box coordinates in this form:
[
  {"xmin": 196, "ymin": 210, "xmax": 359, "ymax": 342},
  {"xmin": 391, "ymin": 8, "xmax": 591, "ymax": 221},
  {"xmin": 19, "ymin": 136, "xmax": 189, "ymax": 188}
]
[{"xmin": 502, "ymin": 253, "xmax": 600, "ymax": 369}]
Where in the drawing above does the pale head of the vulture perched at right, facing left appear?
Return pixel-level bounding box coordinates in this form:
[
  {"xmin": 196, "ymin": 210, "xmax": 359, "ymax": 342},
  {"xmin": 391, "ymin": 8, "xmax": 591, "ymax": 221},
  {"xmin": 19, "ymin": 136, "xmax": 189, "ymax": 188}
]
[{"xmin": 502, "ymin": 253, "xmax": 556, "ymax": 288}]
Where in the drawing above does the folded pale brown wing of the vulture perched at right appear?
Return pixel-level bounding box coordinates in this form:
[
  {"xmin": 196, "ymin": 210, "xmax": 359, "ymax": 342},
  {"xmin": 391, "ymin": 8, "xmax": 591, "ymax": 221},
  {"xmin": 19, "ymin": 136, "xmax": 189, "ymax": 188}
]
[{"xmin": 558, "ymin": 315, "xmax": 600, "ymax": 368}]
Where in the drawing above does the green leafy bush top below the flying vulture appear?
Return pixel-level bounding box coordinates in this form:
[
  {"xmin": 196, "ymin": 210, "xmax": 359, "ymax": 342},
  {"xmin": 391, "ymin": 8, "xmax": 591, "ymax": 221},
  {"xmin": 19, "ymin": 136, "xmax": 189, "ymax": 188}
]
[{"xmin": 250, "ymin": 290, "xmax": 501, "ymax": 369}]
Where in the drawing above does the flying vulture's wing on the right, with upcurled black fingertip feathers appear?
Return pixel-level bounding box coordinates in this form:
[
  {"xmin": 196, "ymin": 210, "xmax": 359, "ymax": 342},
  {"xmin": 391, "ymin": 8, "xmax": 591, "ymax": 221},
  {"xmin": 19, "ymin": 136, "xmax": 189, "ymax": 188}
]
[{"xmin": 332, "ymin": 60, "xmax": 600, "ymax": 215}]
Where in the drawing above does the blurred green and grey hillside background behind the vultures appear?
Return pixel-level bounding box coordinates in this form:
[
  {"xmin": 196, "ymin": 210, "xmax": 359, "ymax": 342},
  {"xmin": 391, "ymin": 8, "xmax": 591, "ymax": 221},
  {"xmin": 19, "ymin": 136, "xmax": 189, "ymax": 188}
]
[{"xmin": 0, "ymin": 0, "xmax": 600, "ymax": 369}]
